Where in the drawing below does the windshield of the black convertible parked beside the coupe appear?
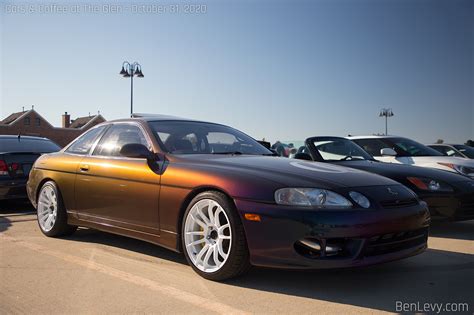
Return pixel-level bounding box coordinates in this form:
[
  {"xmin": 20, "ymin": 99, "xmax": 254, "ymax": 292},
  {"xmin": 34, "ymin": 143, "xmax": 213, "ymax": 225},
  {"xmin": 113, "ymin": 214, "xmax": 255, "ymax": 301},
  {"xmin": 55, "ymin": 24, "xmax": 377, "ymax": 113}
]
[{"xmin": 313, "ymin": 137, "xmax": 373, "ymax": 161}]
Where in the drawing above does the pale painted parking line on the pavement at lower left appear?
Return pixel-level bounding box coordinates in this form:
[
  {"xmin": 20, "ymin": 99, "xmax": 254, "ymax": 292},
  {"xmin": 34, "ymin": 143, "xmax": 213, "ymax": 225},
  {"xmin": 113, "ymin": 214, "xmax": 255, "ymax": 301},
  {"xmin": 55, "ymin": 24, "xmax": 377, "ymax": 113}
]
[{"xmin": 0, "ymin": 233, "xmax": 249, "ymax": 314}]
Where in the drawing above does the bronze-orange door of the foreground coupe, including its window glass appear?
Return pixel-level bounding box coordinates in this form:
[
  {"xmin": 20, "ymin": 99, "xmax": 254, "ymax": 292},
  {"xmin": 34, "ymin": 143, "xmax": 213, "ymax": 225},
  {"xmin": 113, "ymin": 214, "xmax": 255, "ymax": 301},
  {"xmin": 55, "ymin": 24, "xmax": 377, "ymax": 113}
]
[{"xmin": 75, "ymin": 122, "xmax": 160, "ymax": 234}]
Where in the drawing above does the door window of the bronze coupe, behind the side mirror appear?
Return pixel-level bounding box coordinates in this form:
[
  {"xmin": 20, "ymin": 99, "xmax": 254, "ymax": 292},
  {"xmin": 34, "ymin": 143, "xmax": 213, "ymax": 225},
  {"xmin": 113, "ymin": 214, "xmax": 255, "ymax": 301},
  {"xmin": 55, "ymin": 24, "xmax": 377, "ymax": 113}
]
[{"xmin": 92, "ymin": 124, "xmax": 150, "ymax": 156}]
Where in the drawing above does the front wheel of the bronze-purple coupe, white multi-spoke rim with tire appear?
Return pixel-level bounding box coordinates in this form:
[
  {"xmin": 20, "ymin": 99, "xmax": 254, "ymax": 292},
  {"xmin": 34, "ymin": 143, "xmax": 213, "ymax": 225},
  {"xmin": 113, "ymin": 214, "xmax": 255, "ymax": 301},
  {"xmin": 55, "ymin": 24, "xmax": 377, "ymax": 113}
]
[{"xmin": 182, "ymin": 192, "xmax": 250, "ymax": 280}]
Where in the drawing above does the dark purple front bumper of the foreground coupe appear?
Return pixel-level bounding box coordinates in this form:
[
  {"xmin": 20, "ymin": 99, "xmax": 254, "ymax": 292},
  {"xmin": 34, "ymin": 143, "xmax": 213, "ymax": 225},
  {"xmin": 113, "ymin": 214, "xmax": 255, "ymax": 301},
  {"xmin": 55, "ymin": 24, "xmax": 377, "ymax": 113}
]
[{"xmin": 235, "ymin": 200, "xmax": 430, "ymax": 269}]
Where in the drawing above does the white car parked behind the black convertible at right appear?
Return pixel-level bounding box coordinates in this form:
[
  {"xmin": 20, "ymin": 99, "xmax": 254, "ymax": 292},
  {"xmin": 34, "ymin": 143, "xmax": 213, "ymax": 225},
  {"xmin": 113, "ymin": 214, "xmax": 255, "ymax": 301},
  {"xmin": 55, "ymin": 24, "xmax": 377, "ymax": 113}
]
[{"xmin": 347, "ymin": 136, "xmax": 474, "ymax": 179}]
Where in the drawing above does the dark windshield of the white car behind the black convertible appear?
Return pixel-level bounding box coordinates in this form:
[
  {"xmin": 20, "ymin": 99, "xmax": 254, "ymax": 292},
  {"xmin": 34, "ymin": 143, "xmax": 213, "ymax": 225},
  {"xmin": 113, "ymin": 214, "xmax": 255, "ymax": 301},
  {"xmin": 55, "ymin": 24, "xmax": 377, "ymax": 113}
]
[{"xmin": 354, "ymin": 138, "xmax": 443, "ymax": 156}]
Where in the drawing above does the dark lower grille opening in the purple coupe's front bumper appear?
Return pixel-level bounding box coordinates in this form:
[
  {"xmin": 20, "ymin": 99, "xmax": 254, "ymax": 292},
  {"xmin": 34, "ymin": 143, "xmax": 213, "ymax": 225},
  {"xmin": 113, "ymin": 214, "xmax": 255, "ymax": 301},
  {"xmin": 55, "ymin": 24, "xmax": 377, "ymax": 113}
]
[{"xmin": 364, "ymin": 228, "xmax": 428, "ymax": 256}]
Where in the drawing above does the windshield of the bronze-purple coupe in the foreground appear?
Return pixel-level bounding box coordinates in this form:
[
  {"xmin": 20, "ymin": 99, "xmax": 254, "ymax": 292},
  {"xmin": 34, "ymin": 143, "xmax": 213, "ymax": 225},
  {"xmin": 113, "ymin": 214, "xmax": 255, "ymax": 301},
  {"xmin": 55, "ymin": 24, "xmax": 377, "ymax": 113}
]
[{"xmin": 149, "ymin": 120, "xmax": 273, "ymax": 155}]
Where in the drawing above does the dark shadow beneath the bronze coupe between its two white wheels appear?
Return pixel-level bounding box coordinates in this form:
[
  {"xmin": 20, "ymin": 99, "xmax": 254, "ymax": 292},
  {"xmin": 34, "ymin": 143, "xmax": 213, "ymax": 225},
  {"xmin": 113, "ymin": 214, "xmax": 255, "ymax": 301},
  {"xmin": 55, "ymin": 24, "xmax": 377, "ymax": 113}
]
[{"xmin": 63, "ymin": 228, "xmax": 187, "ymax": 265}]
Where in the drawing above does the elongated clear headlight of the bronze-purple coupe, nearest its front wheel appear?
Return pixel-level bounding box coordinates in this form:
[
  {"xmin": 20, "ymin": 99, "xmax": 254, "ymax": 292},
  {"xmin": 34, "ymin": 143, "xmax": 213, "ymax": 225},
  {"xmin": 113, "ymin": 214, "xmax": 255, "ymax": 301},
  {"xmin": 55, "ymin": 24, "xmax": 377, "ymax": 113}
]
[{"xmin": 275, "ymin": 188, "xmax": 352, "ymax": 209}]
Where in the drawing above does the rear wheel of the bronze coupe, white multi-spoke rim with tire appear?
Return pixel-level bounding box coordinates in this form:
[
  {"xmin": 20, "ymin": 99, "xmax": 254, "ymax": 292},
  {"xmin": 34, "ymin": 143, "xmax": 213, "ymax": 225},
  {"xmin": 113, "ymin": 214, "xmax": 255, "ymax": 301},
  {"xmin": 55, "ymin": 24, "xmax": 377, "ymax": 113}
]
[{"xmin": 36, "ymin": 181, "xmax": 77, "ymax": 236}]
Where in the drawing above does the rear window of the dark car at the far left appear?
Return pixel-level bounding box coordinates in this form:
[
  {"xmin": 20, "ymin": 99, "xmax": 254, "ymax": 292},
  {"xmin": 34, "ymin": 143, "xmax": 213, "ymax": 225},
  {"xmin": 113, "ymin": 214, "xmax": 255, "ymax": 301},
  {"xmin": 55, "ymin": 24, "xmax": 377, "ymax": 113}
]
[{"xmin": 0, "ymin": 137, "xmax": 61, "ymax": 153}]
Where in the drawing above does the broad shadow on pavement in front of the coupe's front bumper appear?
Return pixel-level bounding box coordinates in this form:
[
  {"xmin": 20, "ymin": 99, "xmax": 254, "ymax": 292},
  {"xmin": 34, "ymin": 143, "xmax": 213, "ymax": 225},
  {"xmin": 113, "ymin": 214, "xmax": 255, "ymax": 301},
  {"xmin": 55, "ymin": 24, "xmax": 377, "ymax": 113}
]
[{"xmin": 226, "ymin": 249, "xmax": 474, "ymax": 313}]
